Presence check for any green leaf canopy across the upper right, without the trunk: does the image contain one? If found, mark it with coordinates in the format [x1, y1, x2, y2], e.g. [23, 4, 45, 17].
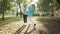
[38, 0, 60, 11]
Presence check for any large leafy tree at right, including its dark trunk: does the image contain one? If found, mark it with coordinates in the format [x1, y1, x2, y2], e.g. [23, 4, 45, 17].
[38, 0, 57, 16]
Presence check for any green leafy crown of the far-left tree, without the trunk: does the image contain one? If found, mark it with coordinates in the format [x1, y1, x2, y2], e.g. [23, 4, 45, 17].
[0, 0, 11, 13]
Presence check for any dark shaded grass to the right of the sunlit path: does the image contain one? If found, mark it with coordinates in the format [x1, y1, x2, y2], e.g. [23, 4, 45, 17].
[37, 17, 60, 34]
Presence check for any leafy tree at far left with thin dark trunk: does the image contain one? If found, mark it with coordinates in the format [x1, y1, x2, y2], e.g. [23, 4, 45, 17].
[0, 0, 10, 20]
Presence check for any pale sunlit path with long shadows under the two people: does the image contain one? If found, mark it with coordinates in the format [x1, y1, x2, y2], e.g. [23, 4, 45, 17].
[0, 17, 48, 34]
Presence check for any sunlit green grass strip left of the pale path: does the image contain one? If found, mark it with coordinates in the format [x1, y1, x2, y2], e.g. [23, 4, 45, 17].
[0, 16, 20, 27]
